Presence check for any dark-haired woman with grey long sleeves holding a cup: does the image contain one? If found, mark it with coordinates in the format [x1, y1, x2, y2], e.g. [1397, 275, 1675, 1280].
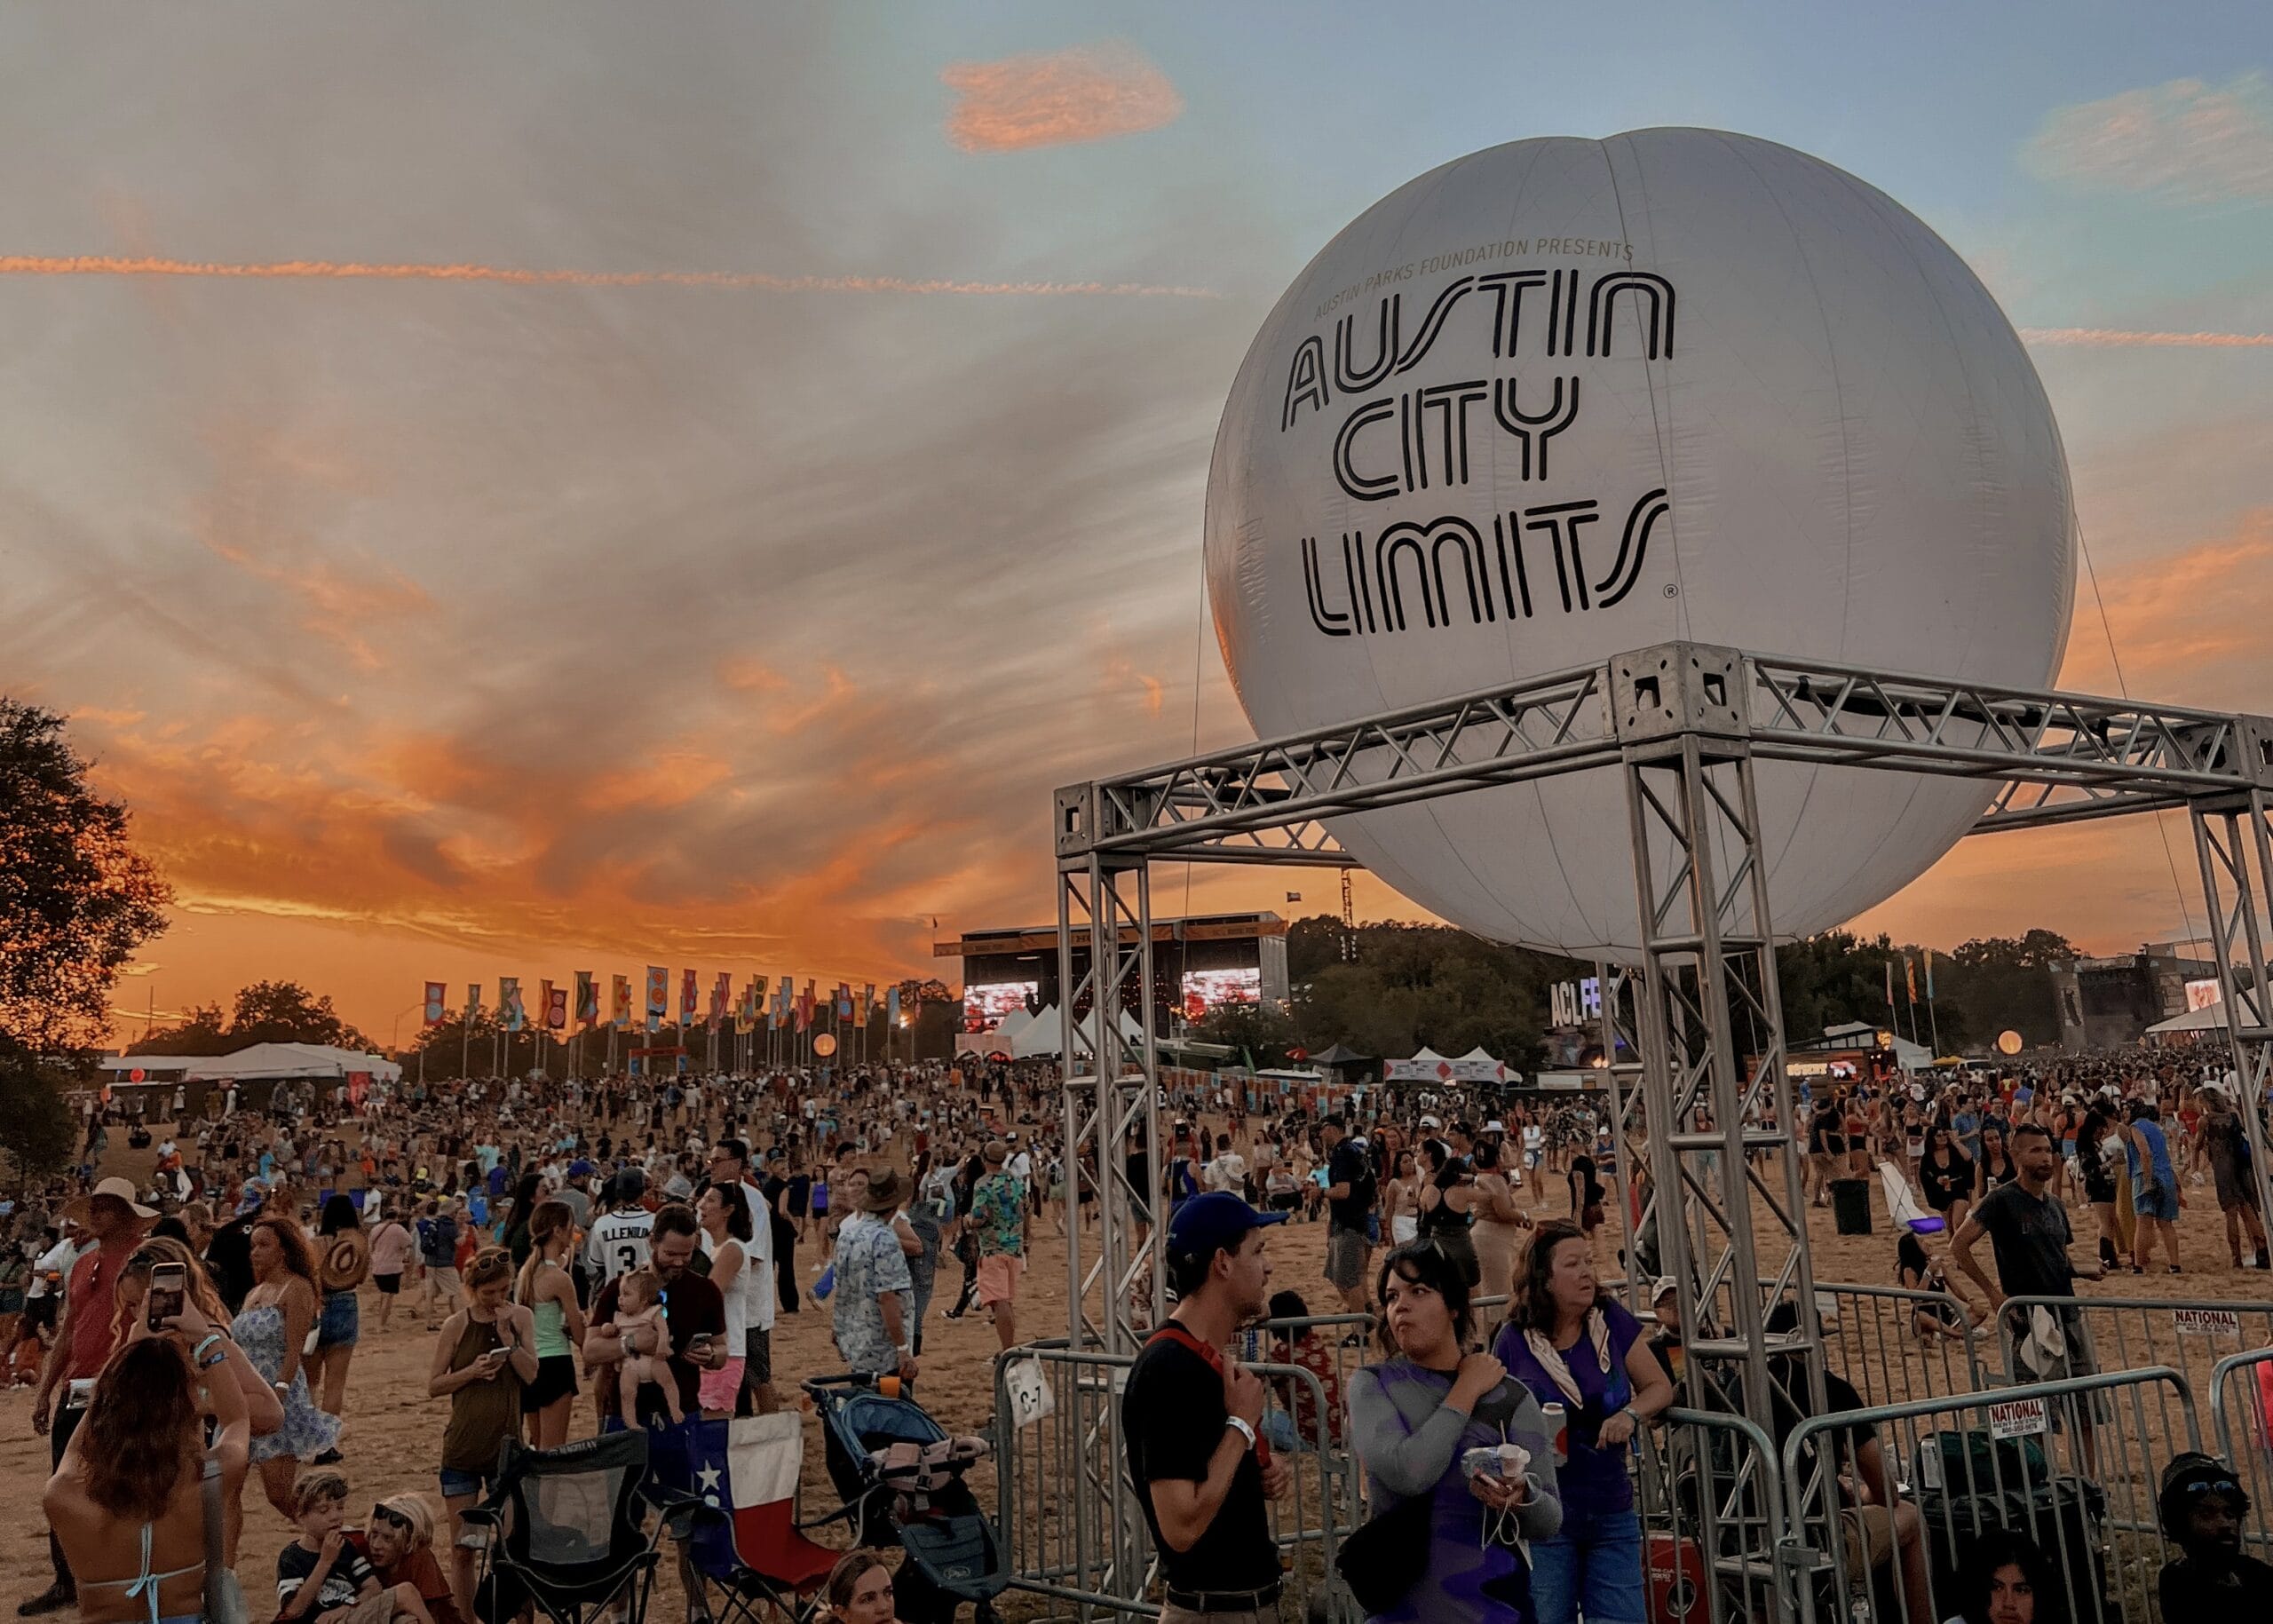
[1350, 1240, 1562, 1624]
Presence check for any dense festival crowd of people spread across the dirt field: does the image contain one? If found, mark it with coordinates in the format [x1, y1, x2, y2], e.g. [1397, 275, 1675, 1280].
[0, 1037, 2273, 1624]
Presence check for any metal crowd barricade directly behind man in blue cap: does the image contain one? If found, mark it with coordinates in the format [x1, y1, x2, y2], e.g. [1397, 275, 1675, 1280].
[994, 1340, 1359, 1624]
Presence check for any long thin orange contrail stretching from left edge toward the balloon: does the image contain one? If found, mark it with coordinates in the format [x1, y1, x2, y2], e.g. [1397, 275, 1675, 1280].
[0, 255, 1218, 298]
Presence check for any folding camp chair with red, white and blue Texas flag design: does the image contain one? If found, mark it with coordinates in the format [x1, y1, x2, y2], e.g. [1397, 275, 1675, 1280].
[648, 1410, 843, 1624]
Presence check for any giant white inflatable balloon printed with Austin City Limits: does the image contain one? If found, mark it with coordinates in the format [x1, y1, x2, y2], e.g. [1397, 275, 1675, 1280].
[1207, 130, 2075, 957]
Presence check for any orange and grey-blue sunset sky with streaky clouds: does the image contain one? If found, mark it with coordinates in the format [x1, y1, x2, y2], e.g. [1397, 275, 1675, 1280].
[0, 0, 2273, 1042]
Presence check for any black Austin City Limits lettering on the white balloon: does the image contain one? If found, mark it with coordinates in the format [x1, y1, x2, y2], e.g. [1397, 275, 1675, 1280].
[1279, 254, 1677, 637]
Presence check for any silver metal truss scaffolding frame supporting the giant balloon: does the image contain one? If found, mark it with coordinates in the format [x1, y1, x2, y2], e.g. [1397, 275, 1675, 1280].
[1052, 644, 2273, 1596]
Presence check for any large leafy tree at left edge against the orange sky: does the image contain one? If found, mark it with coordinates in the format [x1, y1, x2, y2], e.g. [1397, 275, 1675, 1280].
[0, 698, 173, 1053]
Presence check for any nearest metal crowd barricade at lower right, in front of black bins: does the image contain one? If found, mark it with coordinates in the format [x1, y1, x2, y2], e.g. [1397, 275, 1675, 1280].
[1782, 1365, 2200, 1624]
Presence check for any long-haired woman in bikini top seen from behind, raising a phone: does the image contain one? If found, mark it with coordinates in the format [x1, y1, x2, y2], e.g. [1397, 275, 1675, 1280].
[44, 1301, 250, 1624]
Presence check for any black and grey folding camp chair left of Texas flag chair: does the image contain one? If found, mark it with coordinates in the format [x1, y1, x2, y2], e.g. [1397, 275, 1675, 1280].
[463, 1430, 661, 1624]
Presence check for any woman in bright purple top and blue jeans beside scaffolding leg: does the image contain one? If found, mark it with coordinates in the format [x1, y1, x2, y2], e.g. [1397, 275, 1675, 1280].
[1491, 1222, 1673, 1624]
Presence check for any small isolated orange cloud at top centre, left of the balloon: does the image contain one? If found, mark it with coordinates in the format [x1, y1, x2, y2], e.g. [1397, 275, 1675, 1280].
[939, 44, 1184, 153]
